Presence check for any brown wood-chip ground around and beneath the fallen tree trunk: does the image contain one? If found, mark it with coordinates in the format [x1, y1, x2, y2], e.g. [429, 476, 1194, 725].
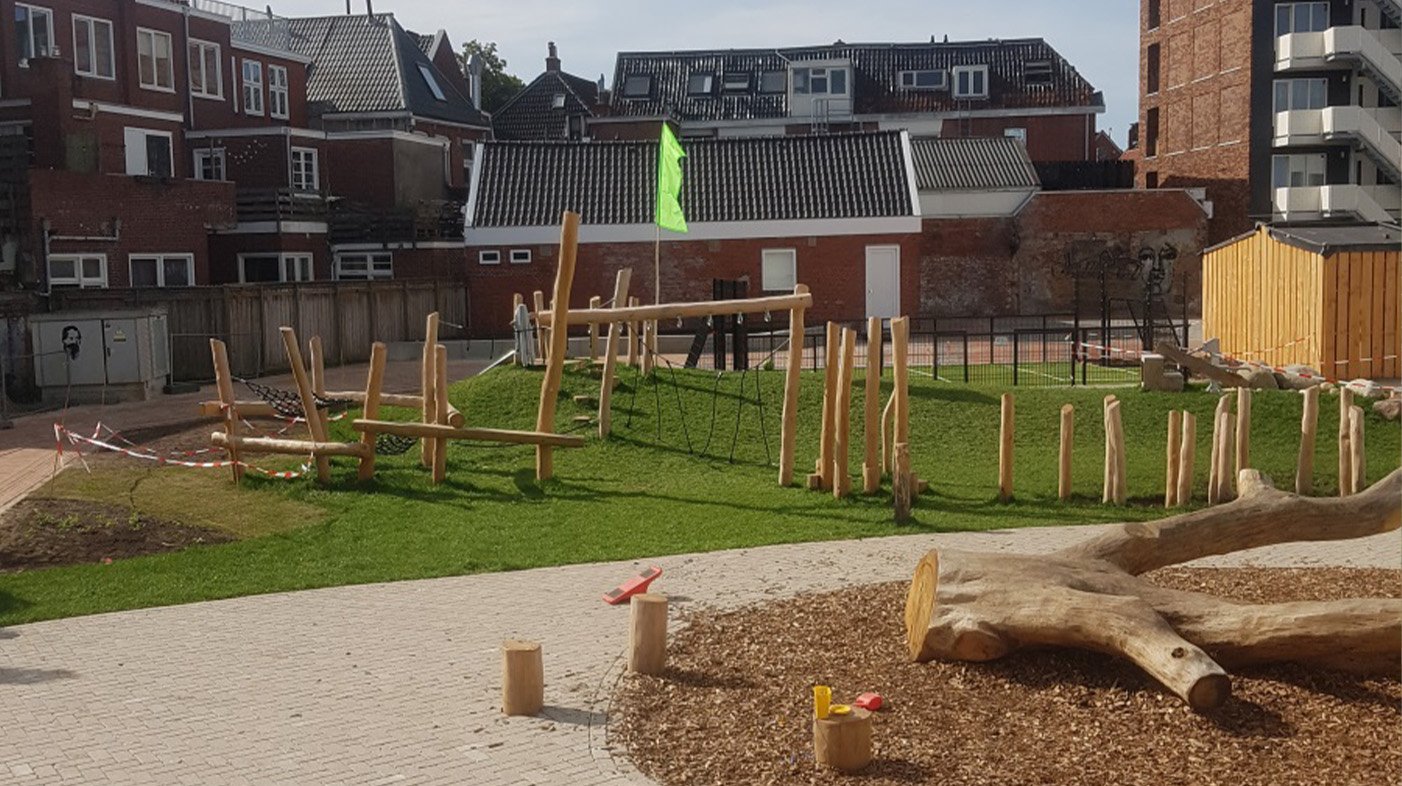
[610, 569, 1402, 786]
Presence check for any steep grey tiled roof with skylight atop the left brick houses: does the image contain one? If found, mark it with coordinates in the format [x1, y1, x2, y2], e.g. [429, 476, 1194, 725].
[234, 14, 489, 127]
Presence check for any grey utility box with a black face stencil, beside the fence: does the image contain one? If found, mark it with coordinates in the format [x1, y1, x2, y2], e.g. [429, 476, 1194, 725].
[29, 308, 171, 404]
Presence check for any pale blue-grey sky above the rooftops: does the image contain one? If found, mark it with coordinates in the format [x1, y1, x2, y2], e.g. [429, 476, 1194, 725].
[278, 0, 1140, 147]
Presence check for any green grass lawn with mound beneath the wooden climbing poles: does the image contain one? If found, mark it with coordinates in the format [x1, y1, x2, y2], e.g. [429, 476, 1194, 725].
[0, 367, 1402, 625]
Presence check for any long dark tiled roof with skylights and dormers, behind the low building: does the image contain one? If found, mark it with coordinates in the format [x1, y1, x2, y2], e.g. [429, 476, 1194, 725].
[611, 38, 1105, 122]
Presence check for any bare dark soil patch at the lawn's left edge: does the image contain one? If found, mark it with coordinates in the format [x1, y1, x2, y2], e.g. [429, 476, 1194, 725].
[0, 499, 233, 572]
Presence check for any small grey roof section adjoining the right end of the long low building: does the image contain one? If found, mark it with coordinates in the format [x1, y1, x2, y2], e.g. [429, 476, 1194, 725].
[910, 136, 1039, 191]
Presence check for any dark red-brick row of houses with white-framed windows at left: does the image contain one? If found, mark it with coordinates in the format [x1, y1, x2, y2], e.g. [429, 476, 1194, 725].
[0, 0, 489, 289]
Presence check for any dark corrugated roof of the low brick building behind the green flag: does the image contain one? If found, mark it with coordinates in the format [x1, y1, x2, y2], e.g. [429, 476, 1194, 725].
[472, 132, 914, 227]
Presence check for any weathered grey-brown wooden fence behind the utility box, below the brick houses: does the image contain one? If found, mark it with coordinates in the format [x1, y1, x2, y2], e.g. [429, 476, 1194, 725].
[53, 280, 467, 381]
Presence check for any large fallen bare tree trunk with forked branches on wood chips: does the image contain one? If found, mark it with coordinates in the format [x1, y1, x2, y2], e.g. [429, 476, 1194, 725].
[906, 469, 1402, 710]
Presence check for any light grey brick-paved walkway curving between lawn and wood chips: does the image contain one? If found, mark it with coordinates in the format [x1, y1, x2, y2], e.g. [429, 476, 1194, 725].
[0, 528, 1402, 786]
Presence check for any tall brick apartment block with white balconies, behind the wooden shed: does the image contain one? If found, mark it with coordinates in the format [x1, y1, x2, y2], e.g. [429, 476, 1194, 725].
[1137, 0, 1402, 242]
